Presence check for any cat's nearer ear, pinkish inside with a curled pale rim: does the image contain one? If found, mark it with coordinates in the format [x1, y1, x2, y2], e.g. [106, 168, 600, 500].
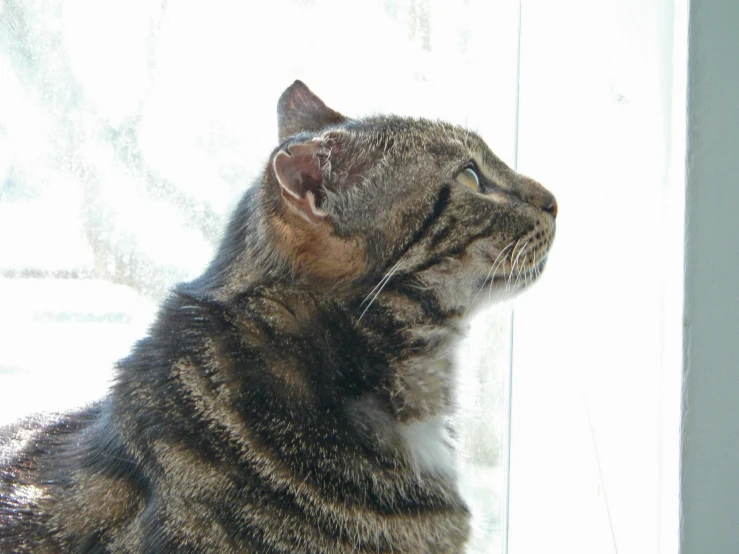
[273, 140, 327, 223]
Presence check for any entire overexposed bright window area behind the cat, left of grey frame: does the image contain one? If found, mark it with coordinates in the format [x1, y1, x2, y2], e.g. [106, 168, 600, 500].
[0, 0, 687, 554]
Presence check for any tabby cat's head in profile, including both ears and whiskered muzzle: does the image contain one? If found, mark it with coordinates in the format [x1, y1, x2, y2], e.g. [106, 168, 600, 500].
[261, 81, 557, 312]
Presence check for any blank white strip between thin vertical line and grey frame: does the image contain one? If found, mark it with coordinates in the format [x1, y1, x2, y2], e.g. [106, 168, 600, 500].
[510, 0, 687, 554]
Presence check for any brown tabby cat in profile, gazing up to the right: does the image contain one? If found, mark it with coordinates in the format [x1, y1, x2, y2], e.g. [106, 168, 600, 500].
[0, 81, 557, 554]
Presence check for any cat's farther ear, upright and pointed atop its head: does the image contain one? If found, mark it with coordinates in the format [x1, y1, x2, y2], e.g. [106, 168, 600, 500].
[277, 81, 347, 142]
